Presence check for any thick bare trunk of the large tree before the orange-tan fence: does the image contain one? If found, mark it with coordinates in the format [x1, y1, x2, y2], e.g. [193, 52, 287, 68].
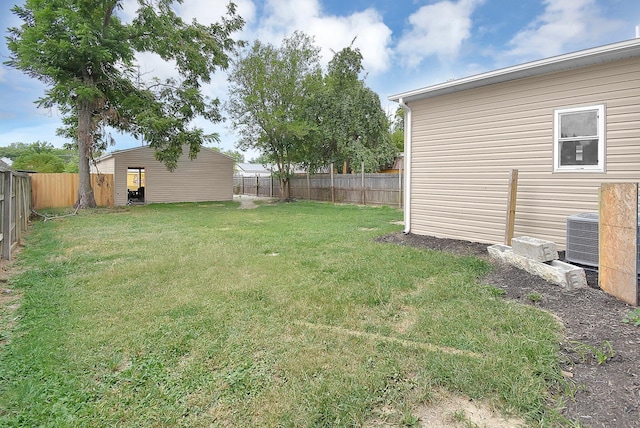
[75, 99, 97, 208]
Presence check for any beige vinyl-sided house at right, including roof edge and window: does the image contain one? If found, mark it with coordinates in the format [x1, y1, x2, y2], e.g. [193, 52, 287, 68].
[389, 39, 640, 248]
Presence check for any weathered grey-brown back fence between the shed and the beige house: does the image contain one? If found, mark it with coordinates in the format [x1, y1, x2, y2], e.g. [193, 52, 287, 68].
[233, 174, 404, 207]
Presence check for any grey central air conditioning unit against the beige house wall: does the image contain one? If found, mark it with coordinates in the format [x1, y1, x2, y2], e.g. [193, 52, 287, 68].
[564, 213, 599, 266]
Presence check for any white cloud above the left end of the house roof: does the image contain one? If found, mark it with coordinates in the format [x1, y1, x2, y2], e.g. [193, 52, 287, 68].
[397, 0, 484, 67]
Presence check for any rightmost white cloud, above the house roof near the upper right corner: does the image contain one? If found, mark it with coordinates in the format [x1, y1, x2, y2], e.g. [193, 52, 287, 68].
[506, 0, 621, 60]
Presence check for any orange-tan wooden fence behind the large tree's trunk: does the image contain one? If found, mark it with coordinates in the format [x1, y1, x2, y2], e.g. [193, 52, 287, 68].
[31, 173, 113, 210]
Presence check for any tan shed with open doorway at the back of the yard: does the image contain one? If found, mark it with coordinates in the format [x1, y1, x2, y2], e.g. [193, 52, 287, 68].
[92, 146, 234, 206]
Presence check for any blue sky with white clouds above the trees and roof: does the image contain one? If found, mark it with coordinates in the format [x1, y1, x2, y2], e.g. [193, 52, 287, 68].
[0, 0, 640, 160]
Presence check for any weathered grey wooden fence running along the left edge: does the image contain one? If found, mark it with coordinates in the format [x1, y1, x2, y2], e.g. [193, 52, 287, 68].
[0, 169, 31, 260]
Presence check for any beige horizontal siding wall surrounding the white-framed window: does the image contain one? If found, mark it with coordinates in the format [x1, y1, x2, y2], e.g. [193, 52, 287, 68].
[409, 58, 640, 248]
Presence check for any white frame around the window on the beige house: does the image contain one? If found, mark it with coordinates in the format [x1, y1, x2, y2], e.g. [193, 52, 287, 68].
[553, 104, 606, 172]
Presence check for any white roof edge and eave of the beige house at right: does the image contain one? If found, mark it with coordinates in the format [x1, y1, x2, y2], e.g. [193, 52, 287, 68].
[389, 39, 640, 103]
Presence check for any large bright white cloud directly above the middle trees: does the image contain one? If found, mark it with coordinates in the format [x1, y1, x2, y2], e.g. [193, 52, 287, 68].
[255, 0, 391, 74]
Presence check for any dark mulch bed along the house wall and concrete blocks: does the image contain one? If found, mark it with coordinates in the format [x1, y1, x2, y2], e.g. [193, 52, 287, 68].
[379, 233, 640, 428]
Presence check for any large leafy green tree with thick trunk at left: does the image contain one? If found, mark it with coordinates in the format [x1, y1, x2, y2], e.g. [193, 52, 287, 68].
[5, 0, 243, 207]
